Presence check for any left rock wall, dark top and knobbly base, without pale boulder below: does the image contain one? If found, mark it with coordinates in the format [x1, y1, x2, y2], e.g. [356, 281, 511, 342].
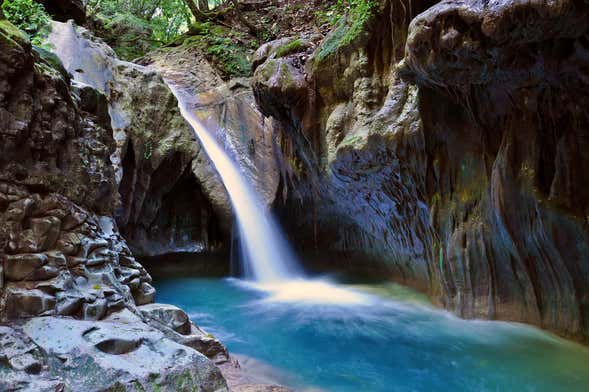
[0, 22, 153, 321]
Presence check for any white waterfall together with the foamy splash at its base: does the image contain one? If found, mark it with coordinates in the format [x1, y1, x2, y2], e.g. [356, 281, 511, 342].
[168, 82, 370, 304]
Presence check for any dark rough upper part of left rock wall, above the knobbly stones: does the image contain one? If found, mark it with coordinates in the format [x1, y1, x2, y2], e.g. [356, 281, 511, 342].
[0, 21, 114, 214]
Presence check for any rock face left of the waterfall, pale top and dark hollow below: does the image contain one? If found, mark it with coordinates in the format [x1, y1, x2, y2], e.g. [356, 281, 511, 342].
[44, 22, 225, 257]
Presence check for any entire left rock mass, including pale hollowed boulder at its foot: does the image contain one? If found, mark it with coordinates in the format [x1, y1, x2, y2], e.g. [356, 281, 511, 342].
[0, 20, 228, 391]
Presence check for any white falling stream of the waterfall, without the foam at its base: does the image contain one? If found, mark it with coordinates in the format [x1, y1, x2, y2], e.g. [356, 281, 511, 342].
[168, 83, 302, 283]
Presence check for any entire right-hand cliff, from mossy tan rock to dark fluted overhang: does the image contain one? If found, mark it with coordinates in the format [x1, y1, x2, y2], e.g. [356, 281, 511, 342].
[252, 0, 589, 339]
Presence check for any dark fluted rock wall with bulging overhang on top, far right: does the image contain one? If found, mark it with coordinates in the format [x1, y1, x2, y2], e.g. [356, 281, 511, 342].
[404, 1, 589, 339]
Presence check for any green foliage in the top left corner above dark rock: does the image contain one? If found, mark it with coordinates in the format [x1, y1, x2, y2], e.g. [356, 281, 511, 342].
[2, 0, 51, 44]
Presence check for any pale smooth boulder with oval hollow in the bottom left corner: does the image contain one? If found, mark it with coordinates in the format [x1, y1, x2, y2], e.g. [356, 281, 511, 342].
[0, 311, 227, 391]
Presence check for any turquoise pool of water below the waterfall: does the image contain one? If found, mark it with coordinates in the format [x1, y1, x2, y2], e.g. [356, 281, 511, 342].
[157, 278, 589, 391]
